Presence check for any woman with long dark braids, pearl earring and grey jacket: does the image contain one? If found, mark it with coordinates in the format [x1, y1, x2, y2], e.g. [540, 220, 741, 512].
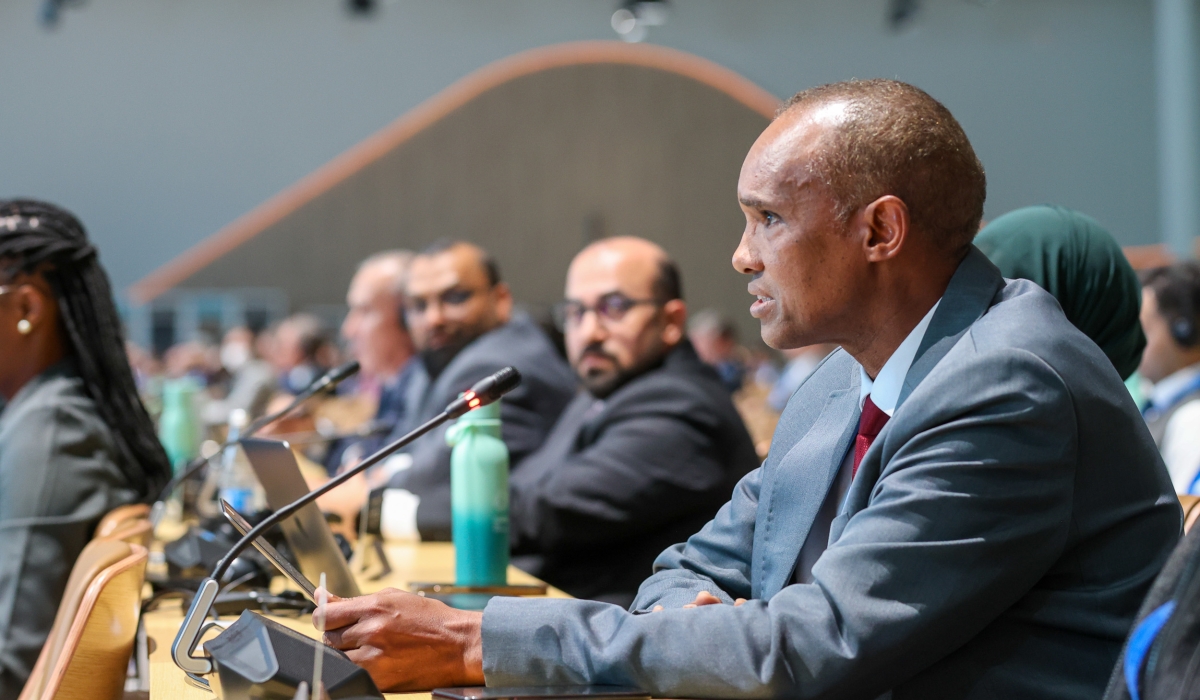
[0, 201, 170, 700]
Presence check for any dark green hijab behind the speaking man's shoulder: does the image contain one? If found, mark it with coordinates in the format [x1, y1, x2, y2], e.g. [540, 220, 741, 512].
[974, 207, 1146, 379]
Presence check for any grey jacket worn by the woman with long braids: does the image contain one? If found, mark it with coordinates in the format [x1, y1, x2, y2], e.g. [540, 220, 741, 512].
[0, 363, 137, 700]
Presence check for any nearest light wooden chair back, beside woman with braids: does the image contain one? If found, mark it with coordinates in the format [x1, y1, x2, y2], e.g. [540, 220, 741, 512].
[19, 539, 146, 700]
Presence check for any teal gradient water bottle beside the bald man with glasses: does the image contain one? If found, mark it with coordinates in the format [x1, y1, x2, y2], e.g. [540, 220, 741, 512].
[446, 401, 509, 586]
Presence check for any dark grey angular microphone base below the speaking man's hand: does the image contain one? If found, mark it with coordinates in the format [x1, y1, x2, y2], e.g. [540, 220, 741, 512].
[204, 610, 383, 700]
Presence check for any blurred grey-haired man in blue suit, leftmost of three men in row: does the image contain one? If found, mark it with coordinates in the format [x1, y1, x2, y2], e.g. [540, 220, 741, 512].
[325, 251, 421, 473]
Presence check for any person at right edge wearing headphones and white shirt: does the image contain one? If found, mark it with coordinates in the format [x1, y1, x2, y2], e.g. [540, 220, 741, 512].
[1140, 262, 1200, 493]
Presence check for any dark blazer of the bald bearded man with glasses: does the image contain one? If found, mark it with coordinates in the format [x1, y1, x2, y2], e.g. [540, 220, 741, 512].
[510, 340, 758, 606]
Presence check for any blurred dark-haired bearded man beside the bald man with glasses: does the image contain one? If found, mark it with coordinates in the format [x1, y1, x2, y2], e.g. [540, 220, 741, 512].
[380, 241, 576, 540]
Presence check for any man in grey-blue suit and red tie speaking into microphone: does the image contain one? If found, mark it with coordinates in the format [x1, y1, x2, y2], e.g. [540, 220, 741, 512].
[316, 80, 1181, 700]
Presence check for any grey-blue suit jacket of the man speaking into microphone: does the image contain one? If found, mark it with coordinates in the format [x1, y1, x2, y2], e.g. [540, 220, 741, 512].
[484, 249, 1181, 700]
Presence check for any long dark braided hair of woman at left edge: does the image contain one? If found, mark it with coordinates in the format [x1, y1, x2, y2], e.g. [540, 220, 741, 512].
[0, 199, 170, 498]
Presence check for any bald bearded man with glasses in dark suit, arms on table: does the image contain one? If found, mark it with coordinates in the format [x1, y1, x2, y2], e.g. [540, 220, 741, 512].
[510, 238, 758, 606]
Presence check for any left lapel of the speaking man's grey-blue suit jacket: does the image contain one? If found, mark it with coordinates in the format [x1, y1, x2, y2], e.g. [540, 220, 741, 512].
[751, 365, 859, 599]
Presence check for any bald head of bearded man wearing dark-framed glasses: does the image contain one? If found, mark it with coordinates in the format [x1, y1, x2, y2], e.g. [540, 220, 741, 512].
[559, 238, 688, 399]
